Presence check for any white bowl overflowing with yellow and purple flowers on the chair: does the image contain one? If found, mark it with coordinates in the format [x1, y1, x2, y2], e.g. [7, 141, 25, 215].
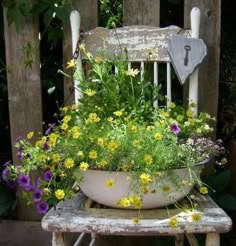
[4, 46, 224, 226]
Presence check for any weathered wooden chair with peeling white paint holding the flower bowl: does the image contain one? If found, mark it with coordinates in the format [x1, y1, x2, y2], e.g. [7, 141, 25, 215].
[42, 8, 232, 246]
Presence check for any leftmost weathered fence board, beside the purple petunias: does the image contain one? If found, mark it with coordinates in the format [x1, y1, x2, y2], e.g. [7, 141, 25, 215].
[4, 6, 42, 220]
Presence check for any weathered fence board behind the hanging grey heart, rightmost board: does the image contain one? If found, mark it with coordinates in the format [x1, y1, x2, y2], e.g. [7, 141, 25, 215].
[184, 0, 221, 135]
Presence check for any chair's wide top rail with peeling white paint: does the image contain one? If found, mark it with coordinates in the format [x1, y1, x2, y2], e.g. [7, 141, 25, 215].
[81, 25, 190, 62]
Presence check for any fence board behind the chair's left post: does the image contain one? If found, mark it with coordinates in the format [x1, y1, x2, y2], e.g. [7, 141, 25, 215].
[63, 0, 98, 104]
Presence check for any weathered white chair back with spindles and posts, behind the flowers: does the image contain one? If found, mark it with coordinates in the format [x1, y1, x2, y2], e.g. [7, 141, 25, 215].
[71, 10, 203, 114]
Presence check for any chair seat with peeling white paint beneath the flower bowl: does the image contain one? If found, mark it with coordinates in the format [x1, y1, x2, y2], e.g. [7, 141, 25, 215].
[42, 192, 232, 236]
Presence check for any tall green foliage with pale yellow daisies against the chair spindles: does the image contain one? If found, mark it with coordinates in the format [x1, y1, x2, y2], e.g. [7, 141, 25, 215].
[76, 45, 160, 120]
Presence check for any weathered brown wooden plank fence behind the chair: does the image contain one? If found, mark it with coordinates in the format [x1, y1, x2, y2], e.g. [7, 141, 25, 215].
[0, 0, 221, 220]
